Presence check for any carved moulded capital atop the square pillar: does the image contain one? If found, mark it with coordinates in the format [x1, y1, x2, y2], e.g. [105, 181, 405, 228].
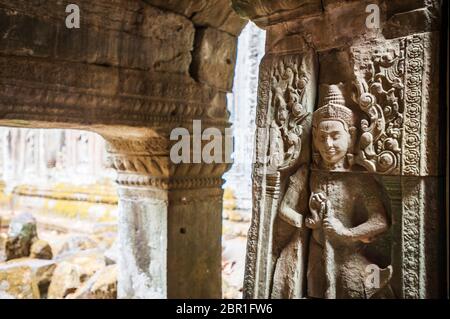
[107, 136, 231, 196]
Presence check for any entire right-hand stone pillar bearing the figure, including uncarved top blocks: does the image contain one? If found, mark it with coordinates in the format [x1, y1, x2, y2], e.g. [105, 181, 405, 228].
[233, 0, 448, 298]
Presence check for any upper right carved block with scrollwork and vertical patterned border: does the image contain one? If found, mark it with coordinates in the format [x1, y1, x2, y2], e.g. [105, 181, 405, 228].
[352, 35, 429, 176]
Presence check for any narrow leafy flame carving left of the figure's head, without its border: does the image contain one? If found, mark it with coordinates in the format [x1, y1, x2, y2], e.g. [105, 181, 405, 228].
[267, 57, 309, 170]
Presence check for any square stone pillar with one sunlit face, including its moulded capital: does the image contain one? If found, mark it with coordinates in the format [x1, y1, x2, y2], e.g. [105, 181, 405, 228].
[107, 131, 229, 298]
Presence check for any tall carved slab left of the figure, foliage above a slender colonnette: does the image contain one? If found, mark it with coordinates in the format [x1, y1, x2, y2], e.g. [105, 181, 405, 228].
[245, 51, 318, 297]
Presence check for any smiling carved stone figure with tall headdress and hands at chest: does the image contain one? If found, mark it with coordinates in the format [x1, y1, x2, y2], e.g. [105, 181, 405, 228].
[272, 85, 392, 298]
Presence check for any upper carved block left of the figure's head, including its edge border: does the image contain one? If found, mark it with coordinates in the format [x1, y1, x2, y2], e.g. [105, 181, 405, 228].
[256, 52, 316, 171]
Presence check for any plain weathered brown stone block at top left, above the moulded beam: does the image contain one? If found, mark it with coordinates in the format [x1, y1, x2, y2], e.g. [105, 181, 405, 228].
[0, 1, 194, 74]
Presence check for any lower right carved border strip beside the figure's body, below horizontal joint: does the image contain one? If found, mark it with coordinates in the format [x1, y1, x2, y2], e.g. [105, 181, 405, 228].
[381, 176, 443, 299]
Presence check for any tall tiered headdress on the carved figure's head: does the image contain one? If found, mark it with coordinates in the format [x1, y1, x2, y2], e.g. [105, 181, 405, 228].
[313, 84, 355, 131]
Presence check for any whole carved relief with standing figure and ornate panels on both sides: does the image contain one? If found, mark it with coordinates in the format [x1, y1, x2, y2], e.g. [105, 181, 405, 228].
[244, 34, 437, 298]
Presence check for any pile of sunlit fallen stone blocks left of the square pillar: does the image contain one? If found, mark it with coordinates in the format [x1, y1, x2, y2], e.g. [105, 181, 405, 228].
[0, 213, 117, 299]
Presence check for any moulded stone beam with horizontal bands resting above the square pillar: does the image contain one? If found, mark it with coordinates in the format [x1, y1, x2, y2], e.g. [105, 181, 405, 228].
[0, 57, 226, 130]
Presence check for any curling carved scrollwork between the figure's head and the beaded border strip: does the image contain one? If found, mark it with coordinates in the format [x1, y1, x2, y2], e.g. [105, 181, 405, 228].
[353, 50, 404, 174]
